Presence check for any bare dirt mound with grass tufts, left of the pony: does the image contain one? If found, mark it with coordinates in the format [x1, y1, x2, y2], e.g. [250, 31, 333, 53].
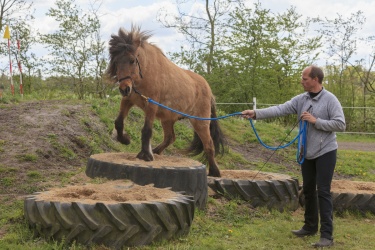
[0, 101, 110, 196]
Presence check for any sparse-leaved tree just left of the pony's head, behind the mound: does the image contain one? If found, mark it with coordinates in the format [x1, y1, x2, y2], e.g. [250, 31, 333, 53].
[41, 0, 104, 99]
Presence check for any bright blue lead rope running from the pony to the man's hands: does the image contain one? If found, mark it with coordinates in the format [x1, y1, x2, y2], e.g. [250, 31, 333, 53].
[146, 97, 307, 164]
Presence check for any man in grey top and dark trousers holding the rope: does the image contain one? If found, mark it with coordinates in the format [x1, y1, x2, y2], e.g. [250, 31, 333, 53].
[242, 66, 346, 247]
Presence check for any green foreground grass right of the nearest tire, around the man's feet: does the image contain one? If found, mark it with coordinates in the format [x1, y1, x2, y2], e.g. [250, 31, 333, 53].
[145, 207, 375, 249]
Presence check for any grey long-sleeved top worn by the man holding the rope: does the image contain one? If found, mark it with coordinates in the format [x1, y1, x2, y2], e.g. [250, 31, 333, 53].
[255, 88, 346, 159]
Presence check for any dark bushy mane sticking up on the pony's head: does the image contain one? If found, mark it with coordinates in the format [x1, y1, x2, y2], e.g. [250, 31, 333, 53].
[107, 25, 152, 78]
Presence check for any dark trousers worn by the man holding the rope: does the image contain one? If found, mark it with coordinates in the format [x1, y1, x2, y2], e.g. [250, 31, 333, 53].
[301, 150, 337, 239]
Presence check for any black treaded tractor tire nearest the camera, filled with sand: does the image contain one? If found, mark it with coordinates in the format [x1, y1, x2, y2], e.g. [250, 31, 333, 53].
[24, 181, 194, 249]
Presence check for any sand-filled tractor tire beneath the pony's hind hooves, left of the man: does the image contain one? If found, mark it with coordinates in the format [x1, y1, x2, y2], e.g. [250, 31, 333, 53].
[208, 170, 299, 211]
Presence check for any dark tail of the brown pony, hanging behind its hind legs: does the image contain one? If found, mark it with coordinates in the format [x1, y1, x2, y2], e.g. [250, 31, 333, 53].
[188, 97, 227, 156]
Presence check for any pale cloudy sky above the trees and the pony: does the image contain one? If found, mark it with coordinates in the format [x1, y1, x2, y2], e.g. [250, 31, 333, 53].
[8, 0, 375, 67]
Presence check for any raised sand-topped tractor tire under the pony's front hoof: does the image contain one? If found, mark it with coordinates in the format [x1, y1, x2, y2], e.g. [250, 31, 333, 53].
[86, 153, 208, 210]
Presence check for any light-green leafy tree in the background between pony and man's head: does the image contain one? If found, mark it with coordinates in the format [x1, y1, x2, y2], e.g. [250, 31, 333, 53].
[211, 4, 276, 105]
